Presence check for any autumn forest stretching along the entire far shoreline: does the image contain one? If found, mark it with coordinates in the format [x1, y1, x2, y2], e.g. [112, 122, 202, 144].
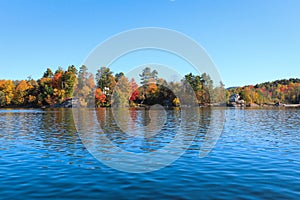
[0, 65, 300, 108]
